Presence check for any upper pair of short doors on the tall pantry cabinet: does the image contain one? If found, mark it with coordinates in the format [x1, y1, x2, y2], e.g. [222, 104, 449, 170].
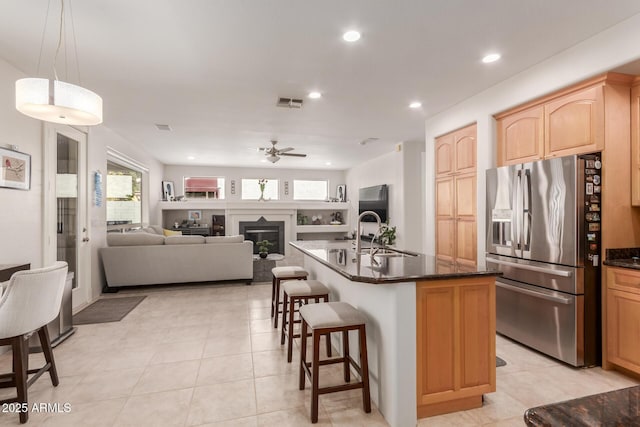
[435, 124, 476, 176]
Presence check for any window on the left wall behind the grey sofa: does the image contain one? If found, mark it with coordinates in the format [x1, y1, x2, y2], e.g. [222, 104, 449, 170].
[106, 161, 142, 229]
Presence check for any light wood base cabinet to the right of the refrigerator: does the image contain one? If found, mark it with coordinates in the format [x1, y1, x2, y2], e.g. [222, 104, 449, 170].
[603, 267, 640, 375]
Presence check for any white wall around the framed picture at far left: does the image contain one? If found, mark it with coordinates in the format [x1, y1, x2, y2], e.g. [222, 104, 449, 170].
[0, 59, 43, 268]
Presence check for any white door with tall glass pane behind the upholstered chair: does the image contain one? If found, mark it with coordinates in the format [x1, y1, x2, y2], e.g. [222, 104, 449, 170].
[43, 123, 91, 310]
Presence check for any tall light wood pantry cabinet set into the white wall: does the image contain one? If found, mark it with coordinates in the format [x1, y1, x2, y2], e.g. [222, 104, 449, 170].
[435, 124, 477, 266]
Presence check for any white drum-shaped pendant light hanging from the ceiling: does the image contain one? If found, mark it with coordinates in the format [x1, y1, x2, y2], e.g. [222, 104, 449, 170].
[16, 0, 102, 126]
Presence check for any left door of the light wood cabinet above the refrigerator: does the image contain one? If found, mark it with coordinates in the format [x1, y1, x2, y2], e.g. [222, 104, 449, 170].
[497, 105, 544, 166]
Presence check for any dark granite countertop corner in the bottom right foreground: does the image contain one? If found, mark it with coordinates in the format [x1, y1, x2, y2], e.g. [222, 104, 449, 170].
[524, 386, 640, 427]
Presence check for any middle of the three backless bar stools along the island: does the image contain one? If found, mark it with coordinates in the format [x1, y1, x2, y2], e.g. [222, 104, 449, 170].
[280, 280, 331, 363]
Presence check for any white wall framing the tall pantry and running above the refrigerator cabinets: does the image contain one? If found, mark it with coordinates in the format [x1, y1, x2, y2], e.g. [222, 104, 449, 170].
[424, 15, 640, 260]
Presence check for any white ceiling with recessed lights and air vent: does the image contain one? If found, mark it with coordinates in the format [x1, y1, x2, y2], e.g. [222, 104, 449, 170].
[0, 0, 640, 169]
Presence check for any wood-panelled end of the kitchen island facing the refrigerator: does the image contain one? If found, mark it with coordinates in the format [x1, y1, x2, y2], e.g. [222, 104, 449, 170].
[416, 277, 496, 418]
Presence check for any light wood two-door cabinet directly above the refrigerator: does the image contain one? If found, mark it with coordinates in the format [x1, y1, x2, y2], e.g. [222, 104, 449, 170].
[495, 73, 633, 166]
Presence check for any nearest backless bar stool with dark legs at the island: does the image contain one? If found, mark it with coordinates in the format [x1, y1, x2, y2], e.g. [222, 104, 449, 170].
[299, 302, 371, 423]
